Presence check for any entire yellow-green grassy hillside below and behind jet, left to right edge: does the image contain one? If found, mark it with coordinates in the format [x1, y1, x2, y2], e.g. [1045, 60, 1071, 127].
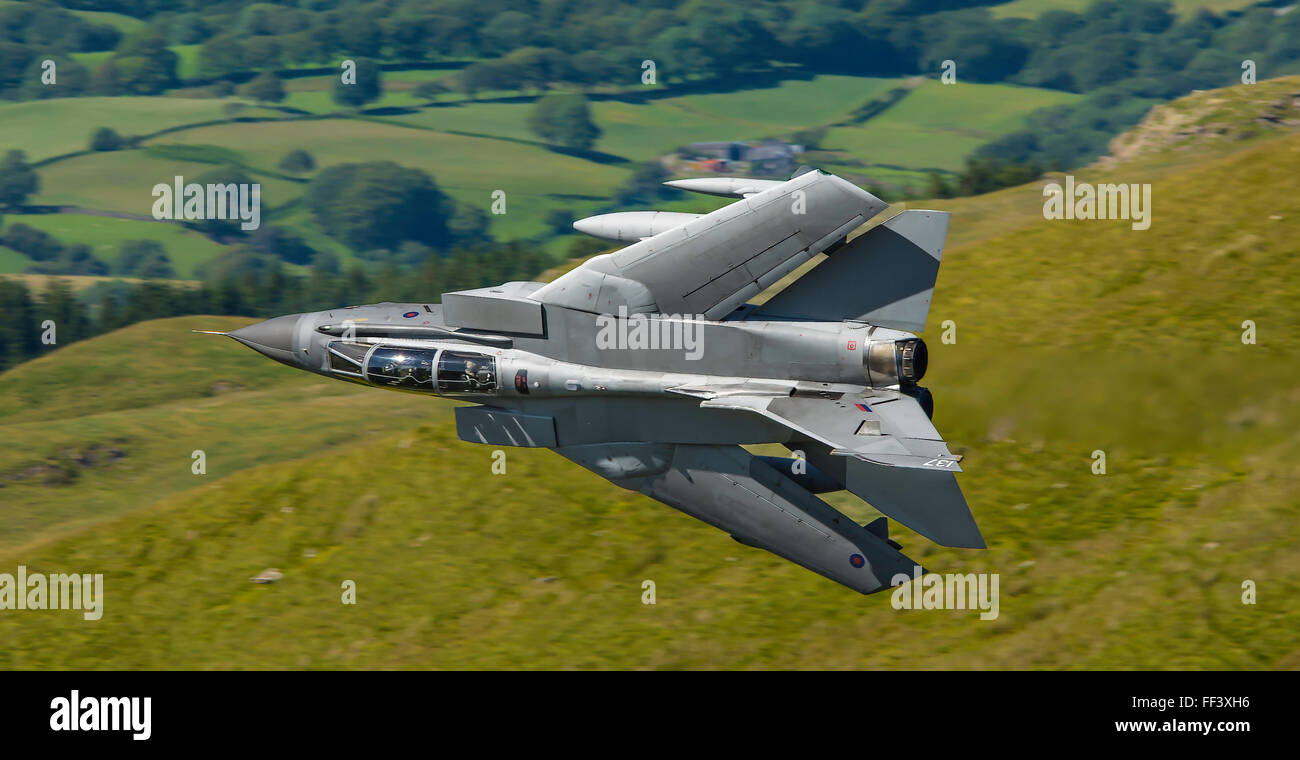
[0, 83, 1300, 669]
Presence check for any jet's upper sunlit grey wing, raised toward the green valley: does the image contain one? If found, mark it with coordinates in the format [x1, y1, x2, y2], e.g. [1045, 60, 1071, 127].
[529, 171, 887, 320]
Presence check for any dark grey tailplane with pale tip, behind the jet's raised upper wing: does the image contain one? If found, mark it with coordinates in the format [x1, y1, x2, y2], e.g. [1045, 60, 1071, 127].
[746, 210, 949, 333]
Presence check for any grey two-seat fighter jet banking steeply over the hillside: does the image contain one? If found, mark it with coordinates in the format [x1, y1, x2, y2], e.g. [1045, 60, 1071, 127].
[208, 170, 984, 594]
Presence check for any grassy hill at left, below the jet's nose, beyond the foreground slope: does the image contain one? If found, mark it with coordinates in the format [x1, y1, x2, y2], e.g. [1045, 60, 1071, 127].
[0, 317, 439, 547]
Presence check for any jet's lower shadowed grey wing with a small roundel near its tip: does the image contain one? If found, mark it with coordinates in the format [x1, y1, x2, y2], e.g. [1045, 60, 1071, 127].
[555, 443, 924, 594]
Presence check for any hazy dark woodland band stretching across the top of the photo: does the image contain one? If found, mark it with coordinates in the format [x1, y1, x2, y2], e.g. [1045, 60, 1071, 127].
[10, 0, 1300, 103]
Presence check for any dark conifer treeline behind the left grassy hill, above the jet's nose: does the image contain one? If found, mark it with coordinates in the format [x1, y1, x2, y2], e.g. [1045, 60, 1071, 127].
[0, 243, 553, 372]
